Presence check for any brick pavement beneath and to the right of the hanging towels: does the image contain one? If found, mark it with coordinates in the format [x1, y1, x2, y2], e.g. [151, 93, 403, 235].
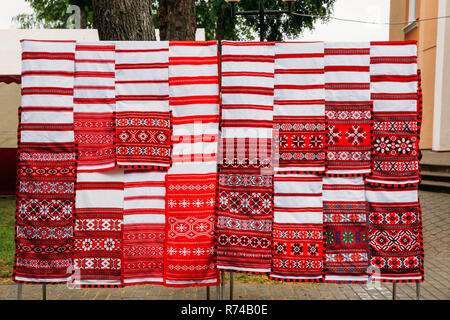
[0, 192, 450, 300]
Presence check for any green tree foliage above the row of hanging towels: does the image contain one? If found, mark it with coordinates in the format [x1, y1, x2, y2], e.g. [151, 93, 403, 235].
[14, 0, 335, 41]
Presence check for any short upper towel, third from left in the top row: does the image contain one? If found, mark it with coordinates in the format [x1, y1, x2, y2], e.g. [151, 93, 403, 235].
[116, 41, 171, 170]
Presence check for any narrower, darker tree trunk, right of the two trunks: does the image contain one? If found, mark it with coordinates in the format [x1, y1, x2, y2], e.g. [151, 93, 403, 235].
[158, 0, 197, 40]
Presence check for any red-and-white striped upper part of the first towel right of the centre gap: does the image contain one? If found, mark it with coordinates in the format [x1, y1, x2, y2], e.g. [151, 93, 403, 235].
[221, 41, 275, 138]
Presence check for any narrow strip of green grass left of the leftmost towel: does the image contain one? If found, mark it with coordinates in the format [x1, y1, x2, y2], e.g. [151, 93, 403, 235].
[0, 197, 16, 282]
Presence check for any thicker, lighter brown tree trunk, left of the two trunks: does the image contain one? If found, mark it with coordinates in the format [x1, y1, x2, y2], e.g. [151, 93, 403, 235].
[92, 0, 156, 40]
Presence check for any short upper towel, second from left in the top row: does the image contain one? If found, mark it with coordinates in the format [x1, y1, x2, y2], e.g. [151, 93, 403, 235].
[73, 42, 115, 172]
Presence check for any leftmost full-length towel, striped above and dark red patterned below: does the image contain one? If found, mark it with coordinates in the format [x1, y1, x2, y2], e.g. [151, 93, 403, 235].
[13, 40, 76, 283]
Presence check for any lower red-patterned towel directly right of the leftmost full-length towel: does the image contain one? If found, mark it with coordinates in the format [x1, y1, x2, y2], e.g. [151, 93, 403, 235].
[73, 168, 124, 287]
